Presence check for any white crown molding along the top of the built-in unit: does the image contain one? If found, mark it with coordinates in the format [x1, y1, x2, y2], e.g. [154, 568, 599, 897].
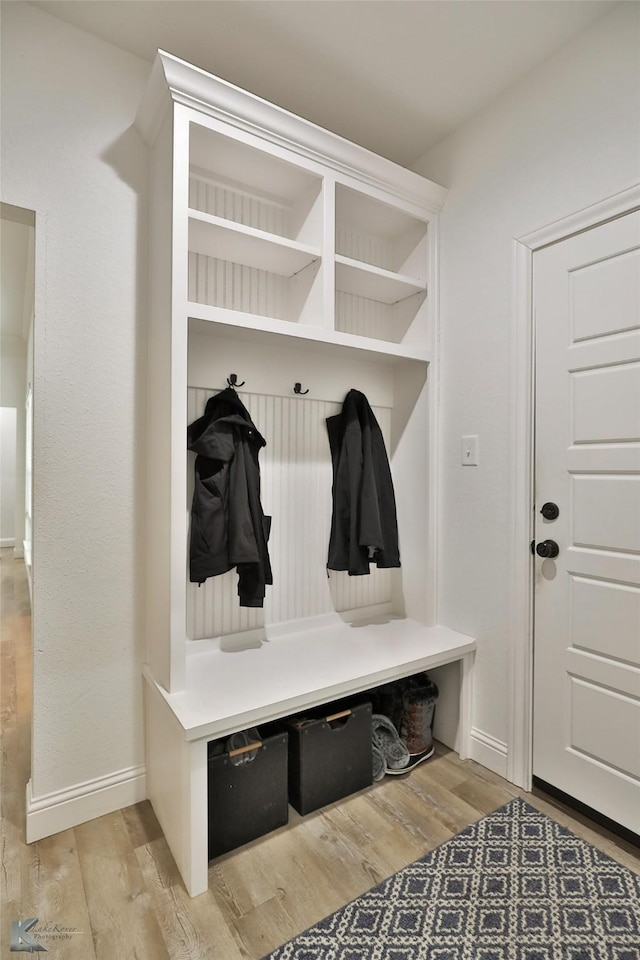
[135, 50, 448, 213]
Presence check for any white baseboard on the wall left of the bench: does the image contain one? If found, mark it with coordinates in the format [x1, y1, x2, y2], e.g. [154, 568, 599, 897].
[27, 766, 147, 843]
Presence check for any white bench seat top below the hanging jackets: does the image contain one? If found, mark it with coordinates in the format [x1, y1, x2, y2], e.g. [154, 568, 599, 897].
[145, 617, 476, 740]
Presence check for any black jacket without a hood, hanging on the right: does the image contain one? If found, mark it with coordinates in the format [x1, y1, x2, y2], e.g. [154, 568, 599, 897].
[327, 390, 400, 576]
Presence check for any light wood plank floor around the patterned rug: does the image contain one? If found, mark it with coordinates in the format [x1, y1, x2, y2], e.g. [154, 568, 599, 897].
[0, 550, 640, 960]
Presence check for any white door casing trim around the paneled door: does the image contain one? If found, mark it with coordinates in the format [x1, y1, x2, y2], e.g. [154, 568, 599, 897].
[508, 183, 640, 790]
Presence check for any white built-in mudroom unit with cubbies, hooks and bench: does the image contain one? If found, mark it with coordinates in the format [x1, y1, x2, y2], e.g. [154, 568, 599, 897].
[137, 52, 475, 896]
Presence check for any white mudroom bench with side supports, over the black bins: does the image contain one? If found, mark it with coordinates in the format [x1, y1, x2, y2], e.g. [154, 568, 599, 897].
[145, 615, 476, 896]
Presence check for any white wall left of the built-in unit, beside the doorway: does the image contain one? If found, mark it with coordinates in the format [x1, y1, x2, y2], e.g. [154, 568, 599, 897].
[1, 3, 149, 824]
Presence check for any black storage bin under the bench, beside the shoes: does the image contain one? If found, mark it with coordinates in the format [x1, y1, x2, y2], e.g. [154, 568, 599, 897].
[287, 703, 373, 814]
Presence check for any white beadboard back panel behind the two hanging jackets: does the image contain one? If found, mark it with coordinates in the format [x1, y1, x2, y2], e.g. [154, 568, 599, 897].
[187, 387, 391, 640]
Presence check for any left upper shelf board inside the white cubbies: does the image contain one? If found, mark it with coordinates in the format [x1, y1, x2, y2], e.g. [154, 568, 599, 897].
[189, 210, 320, 277]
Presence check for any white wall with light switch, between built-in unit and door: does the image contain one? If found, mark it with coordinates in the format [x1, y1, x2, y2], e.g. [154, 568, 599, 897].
[416, 3, 640, 772]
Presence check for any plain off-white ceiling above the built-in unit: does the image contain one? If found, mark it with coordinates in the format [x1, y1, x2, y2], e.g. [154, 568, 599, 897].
[33, 0, 614, 166]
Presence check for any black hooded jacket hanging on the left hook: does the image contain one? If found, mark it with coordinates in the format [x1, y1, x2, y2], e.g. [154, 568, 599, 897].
[187, 389, 273, 607]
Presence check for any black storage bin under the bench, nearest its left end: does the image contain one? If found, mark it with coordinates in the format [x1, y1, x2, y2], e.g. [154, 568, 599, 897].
[208, 727, 289, 860]
